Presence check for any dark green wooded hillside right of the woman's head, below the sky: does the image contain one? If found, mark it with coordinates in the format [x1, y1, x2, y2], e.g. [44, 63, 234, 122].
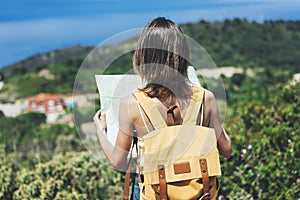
[183, 19, 300, 70]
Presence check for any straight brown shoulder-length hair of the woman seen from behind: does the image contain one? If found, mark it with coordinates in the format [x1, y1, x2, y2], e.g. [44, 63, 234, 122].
[133, 17, 192, 106]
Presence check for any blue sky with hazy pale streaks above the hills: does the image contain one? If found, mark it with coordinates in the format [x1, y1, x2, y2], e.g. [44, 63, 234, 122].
[0, 0, 300, 67]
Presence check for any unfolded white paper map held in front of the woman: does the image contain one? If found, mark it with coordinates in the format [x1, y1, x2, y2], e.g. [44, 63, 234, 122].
[95, 66, 200, 145]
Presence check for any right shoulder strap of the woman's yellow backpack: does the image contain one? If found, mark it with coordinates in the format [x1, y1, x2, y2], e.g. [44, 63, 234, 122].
[183, 86, 204, 124]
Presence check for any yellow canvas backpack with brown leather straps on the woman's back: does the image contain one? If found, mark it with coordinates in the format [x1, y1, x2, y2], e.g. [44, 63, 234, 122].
[134, 87, 221, 200]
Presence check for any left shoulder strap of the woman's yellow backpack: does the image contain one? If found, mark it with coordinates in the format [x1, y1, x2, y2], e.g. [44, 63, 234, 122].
[133, 91, 167, 130]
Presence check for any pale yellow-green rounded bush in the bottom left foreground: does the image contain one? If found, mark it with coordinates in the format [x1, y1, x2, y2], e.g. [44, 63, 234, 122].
[13, 153, 122, 199]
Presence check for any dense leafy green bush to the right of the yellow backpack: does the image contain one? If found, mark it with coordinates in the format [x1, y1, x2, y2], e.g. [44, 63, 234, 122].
[220, 84, 300, 199]
